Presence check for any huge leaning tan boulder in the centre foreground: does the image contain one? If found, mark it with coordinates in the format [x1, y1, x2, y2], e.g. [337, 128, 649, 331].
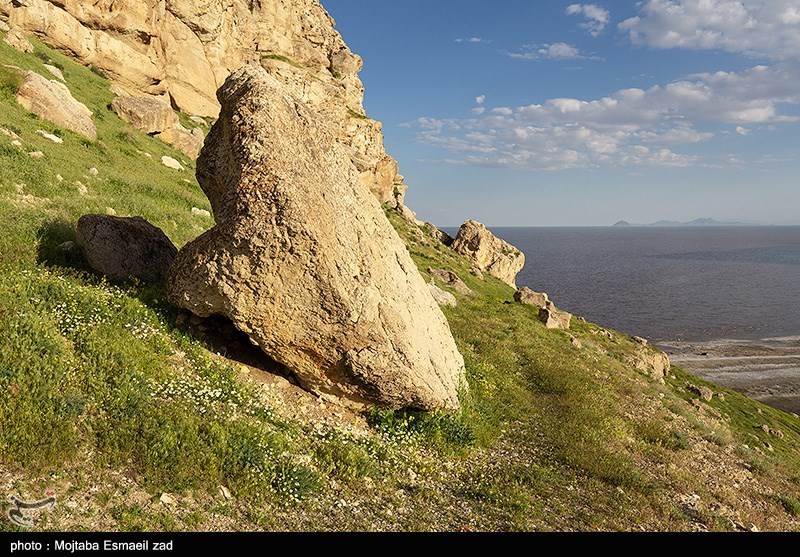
[167, 65, 464, 409]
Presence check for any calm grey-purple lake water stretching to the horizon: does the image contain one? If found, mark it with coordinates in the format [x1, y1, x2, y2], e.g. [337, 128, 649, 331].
[448, 227, 800, 342]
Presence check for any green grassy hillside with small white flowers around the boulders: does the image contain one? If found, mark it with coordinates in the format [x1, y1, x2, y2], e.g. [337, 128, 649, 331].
[0, 26, 800, 530]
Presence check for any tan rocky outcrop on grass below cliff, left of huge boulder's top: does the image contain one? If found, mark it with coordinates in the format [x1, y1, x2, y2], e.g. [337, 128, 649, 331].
[111, 95, 205, 159]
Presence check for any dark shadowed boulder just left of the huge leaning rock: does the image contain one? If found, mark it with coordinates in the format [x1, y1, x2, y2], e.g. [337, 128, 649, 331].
[77, 215, 178, 284]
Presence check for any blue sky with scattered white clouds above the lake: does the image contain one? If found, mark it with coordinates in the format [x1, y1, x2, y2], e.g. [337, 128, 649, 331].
[323, 0, 800, 226]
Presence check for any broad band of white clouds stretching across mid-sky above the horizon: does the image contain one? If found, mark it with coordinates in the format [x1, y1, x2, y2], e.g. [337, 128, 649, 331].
[415, 66, 800, 169]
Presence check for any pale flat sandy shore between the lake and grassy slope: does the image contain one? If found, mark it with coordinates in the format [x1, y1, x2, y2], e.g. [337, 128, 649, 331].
[658, 336, 800, 414]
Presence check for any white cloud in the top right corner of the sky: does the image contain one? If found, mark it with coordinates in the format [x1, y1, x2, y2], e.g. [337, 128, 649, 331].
[619, 0, 800, 60]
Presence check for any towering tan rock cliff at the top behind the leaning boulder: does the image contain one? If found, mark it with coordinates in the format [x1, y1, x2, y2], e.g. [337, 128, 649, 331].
[0, 0, 403, 203]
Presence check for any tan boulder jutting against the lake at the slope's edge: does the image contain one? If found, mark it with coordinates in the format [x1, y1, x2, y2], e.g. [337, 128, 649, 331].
[452, 220, 525, 287]
